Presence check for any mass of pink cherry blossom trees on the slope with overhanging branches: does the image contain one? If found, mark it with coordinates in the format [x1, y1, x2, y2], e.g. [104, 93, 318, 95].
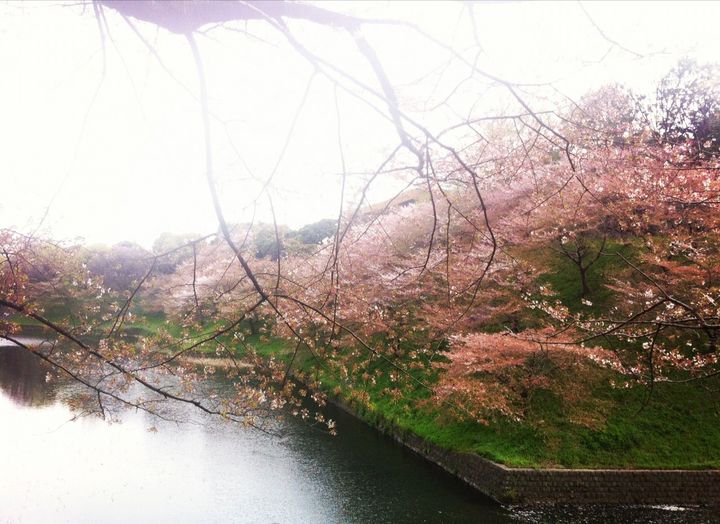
[0, 0, 720, 429]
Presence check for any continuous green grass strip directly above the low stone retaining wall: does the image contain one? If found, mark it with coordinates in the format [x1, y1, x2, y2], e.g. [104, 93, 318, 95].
[288, 342, 720, 469]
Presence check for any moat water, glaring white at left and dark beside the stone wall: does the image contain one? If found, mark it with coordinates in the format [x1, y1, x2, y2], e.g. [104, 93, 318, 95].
[0, 347, 720, 524]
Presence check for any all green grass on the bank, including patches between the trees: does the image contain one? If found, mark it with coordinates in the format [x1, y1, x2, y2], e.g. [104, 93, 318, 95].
[14, 244, 720, 469]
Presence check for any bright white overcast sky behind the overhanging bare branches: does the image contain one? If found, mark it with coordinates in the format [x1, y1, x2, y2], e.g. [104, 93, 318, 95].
[0, 2, 720, 247]
